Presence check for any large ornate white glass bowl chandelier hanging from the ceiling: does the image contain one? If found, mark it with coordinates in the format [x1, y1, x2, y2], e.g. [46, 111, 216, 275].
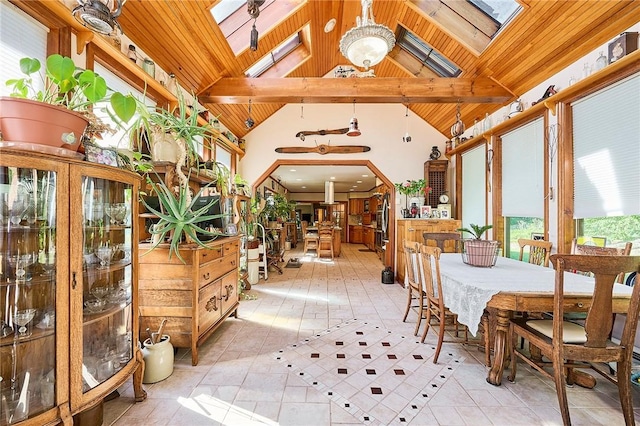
[340, 0, 396, 70]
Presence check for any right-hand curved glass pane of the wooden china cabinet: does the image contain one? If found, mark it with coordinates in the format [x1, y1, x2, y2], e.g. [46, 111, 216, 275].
[82, 176, 134, 392]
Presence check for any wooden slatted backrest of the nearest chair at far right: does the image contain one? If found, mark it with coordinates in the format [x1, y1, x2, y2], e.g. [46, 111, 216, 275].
[551, 254, 640, 350]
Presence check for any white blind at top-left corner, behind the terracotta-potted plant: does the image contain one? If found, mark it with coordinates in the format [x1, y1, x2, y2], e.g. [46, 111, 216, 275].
[0, 1, 48, 96]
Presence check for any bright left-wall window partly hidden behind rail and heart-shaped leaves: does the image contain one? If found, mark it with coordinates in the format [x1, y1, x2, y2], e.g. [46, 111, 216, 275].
[93, 62, 156, 148]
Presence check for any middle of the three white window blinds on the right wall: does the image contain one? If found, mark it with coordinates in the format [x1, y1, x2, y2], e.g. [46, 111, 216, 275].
[502, 118, 544, 217]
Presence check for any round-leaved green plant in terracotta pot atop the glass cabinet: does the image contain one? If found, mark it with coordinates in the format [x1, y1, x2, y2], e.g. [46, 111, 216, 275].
[0, 54, 136, 151]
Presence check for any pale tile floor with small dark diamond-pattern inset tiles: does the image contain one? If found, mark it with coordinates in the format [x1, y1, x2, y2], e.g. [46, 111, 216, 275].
[104, 244, 640, 426]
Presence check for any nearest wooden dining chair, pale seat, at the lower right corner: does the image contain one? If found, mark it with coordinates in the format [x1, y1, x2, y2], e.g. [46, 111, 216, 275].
[508, 254, 640, 425]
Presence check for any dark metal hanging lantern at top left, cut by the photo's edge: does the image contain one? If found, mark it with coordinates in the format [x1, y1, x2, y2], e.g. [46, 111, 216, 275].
[71, 0, 127, 35]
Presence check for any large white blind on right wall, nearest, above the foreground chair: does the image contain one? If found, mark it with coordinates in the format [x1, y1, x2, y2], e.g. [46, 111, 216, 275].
[571, 74, 640, 218]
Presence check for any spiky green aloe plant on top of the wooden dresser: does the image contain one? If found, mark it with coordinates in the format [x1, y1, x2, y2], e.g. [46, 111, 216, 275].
[140, 178, 224, 263]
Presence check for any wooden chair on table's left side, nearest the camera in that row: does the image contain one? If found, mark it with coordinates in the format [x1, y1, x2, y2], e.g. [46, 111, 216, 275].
[420, 245, 491, 366]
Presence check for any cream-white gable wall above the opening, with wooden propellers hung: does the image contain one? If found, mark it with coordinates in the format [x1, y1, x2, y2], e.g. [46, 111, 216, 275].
[239, 104, 454, 190]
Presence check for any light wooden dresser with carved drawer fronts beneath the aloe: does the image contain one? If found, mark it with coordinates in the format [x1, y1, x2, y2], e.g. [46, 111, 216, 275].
[139, 236, 240, 365]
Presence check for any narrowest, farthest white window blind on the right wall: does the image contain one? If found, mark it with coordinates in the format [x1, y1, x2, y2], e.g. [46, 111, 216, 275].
[462, 145, 487, 228]
